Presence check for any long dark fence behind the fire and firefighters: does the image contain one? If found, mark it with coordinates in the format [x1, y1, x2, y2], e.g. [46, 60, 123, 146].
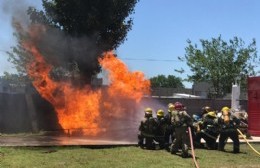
[0, 93, 247, 133]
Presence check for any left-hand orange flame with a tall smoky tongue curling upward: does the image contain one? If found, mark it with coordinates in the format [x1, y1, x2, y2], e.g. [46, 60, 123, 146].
[24, 43, 101, 135]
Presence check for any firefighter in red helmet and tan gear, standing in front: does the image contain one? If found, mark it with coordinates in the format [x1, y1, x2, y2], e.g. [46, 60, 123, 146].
[170, 102, 192, 158]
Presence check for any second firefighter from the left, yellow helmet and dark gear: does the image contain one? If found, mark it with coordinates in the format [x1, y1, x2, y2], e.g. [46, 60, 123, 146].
[155, 109, 167, 149]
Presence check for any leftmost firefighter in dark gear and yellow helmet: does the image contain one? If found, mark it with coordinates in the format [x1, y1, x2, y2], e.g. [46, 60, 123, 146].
[138, 107, 156, 149]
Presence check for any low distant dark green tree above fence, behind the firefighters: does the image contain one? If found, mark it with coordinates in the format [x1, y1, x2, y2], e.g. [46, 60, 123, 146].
[150, 75, 184, 88]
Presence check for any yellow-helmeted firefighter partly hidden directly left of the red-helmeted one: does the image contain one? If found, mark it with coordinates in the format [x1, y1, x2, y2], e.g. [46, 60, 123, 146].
[164, 103, 175, 150]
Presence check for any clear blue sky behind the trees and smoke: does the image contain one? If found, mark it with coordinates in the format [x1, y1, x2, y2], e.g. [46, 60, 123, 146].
[0, 0, 260, 88]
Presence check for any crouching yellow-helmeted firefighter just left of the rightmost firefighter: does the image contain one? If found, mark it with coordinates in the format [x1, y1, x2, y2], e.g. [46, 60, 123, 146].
[194, 111, 219, 150]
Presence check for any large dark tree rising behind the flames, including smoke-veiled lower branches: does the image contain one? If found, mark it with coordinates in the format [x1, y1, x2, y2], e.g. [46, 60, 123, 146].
[9, 0, 138, 83]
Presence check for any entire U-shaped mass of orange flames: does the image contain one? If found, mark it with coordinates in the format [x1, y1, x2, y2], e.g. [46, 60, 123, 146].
[23, 25, 150, 135]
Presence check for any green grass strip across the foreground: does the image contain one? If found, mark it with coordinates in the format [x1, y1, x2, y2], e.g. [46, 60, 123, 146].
[0, 144, 260, 168]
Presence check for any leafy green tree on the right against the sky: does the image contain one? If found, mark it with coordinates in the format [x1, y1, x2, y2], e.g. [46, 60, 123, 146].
[185, 35, 259, 97]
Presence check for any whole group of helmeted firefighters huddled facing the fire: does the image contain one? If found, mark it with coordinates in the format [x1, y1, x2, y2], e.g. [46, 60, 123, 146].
[138, 102, 243, 158]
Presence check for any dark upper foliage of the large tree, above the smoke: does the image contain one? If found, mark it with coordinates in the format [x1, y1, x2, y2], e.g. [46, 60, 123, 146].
[39, 0, 137, 51]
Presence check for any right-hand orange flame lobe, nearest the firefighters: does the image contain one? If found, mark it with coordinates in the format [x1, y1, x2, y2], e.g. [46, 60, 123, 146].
[99, 52, 150, 102]
